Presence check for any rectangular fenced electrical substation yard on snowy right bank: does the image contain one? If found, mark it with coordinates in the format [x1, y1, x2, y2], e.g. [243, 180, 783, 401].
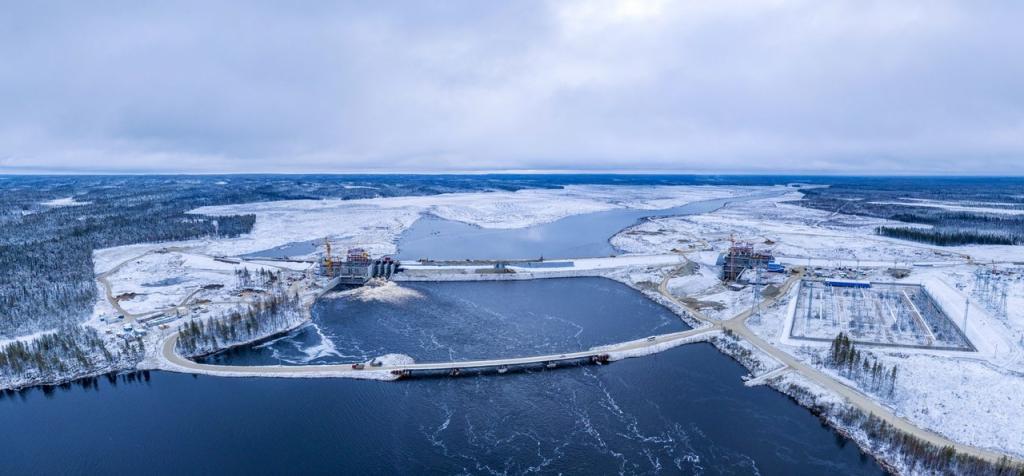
[790, 279, 974, 351]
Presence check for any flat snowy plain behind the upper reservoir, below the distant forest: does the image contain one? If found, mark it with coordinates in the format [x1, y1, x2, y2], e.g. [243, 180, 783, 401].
[194, 185, 770, 260]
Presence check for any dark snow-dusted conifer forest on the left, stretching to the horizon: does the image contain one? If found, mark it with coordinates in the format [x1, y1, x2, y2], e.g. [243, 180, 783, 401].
[0, 175, 569, 340]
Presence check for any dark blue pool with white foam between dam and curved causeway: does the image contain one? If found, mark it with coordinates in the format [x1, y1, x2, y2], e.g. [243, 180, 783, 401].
[200, 277, 689, 364]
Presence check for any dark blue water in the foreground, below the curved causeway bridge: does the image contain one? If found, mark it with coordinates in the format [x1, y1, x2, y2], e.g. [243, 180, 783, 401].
[0, 344, 882, 475]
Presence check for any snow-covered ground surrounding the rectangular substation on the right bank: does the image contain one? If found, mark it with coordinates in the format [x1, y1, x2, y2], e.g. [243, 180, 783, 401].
[612, 190, 1024, 456]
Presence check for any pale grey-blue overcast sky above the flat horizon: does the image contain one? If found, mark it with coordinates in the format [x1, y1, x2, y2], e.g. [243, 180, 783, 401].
[0, 0, 1024, 175]
